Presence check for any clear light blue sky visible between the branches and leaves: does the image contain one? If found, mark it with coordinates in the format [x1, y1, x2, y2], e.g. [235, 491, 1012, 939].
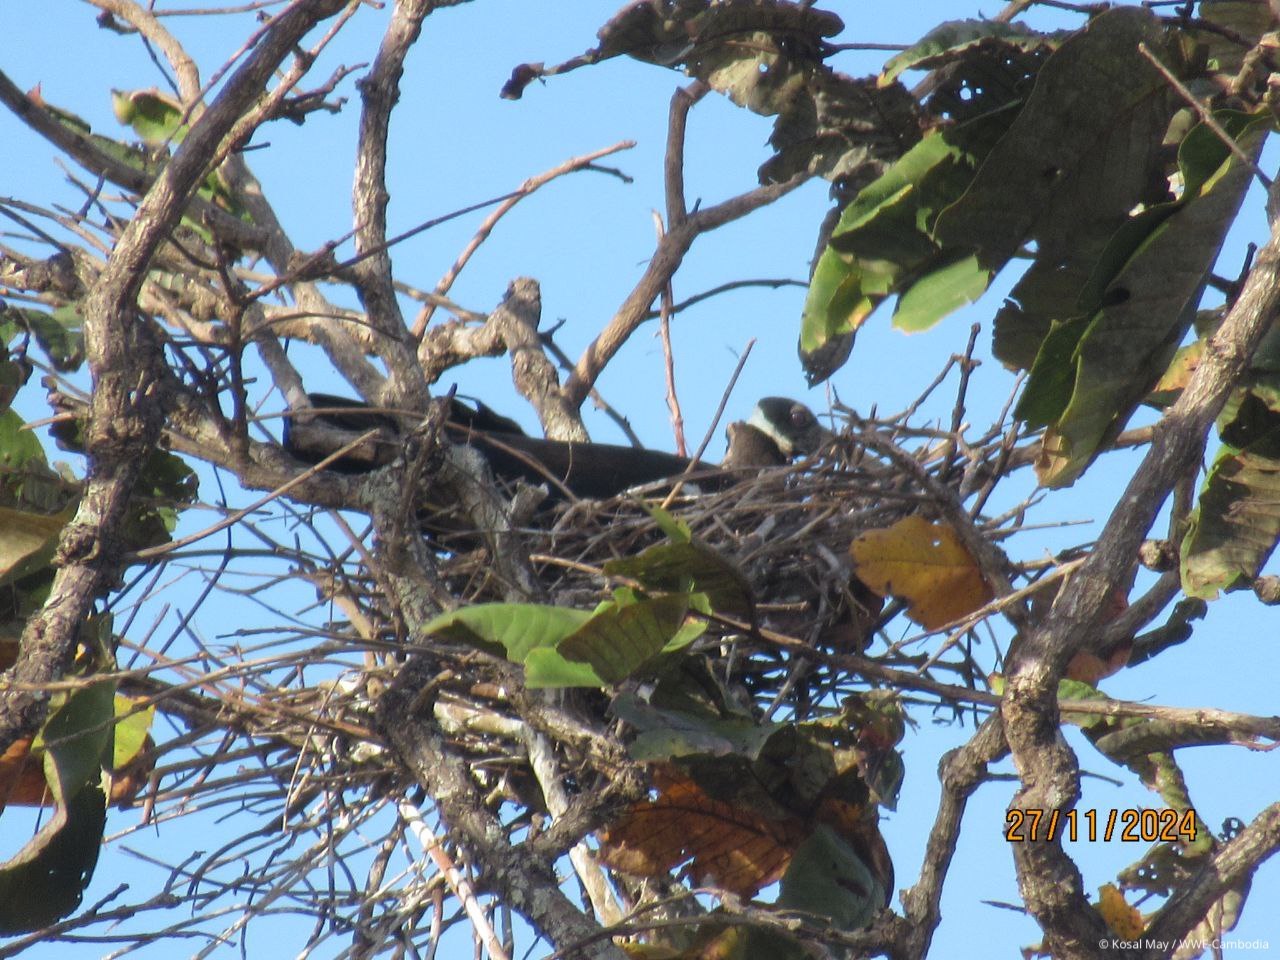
[0, 0, 1280, 959]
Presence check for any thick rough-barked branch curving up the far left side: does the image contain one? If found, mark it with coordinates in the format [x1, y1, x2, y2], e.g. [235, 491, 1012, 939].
[0, 0, 343, 748]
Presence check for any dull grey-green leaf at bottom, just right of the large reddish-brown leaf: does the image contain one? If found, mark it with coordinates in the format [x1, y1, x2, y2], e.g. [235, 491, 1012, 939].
[778, 824, 886, 931]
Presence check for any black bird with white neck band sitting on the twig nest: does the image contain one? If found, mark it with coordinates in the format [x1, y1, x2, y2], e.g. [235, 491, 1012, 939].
[284, 393, 831, 499]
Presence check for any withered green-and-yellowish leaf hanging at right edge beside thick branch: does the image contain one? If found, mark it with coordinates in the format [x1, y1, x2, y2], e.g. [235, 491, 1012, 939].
[1181, 392, 1280, 600]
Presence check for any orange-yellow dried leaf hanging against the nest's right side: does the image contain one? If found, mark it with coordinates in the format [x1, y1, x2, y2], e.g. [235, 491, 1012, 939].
[849, 517, 993, 630]
